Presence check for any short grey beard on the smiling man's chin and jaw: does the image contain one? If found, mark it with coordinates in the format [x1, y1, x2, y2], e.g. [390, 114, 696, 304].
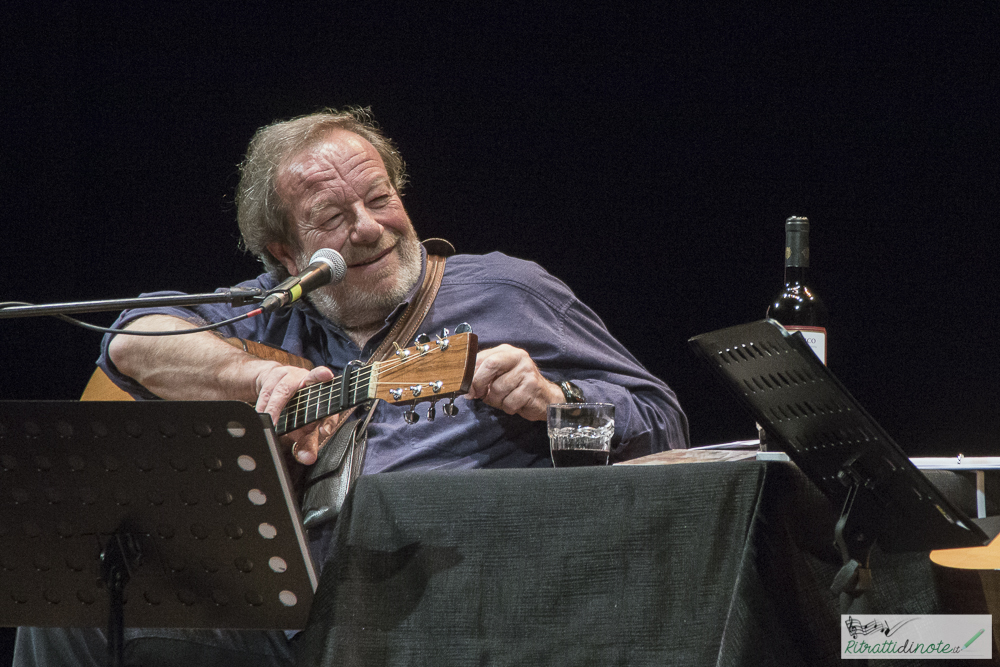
[307, 233, 420, 331]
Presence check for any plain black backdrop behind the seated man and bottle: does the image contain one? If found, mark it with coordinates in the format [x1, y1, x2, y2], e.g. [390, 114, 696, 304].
[0, 0, 1000, 656]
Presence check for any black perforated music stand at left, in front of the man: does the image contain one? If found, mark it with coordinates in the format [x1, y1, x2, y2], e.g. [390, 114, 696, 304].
[0, 401, 317, 662]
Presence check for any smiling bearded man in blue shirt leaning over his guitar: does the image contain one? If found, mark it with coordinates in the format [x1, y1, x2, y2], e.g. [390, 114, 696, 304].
[16, 110, 688, 665]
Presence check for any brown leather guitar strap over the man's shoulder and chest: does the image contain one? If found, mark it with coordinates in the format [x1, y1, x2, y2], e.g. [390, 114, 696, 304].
[350, 239, 455, 486]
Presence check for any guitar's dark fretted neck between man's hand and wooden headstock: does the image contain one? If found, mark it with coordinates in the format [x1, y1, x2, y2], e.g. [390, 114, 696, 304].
[274, 363, 378, 435]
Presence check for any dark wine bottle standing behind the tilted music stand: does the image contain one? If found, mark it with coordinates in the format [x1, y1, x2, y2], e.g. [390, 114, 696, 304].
[767, 216, 827, 364]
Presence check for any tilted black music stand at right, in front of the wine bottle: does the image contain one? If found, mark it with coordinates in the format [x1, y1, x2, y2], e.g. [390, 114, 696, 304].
[688, 319, 1000, 604]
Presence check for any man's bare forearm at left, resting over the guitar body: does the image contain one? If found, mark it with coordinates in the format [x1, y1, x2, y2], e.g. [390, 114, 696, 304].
[108, 315, 281, 403]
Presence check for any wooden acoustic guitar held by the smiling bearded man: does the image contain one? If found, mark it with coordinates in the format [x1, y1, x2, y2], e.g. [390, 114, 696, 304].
[81, 332, 479, 435]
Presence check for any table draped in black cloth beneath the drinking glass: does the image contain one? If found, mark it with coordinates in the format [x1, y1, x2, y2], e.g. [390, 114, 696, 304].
[297, 461, 986, 667]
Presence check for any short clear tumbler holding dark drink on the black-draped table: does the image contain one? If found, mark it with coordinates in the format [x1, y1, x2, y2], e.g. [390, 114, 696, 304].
[548, 403, 615, 468]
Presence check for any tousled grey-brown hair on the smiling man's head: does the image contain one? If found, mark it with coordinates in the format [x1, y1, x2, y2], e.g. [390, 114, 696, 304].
[236, 107, 406, 279]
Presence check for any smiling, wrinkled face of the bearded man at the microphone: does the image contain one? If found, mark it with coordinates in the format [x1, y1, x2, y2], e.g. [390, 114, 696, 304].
[268, 130, 420, 328]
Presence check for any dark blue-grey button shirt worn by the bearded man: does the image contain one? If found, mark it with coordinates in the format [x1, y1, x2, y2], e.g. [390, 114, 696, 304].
[98, 252, 688, 474]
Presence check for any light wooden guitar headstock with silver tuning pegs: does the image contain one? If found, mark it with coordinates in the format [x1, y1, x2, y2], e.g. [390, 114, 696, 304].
[375, 325, 479, 423]
